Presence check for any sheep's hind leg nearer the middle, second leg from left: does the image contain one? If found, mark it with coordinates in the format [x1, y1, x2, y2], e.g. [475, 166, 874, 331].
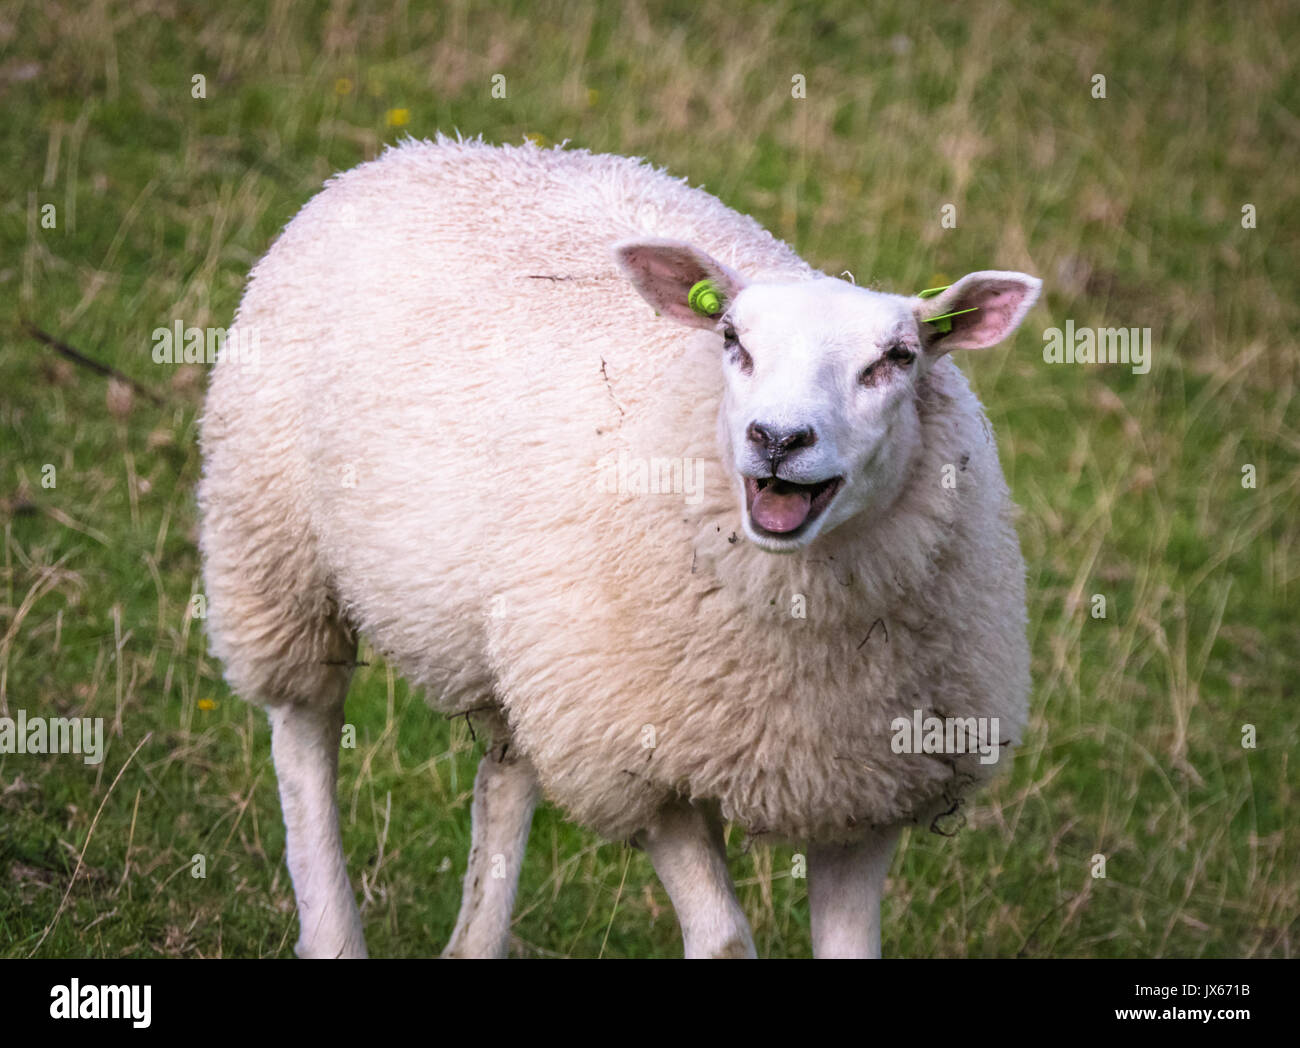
[442, 742, 538, 957]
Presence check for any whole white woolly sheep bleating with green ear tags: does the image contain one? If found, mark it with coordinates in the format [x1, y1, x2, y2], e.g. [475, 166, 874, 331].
[199, 135, 1040, 957]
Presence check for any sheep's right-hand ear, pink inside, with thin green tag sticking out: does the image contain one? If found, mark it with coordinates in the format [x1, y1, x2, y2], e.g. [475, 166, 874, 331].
[913, 269, 1043, 355]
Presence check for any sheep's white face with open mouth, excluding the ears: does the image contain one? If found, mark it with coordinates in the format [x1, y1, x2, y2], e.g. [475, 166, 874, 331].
[718, 280, 931, 551]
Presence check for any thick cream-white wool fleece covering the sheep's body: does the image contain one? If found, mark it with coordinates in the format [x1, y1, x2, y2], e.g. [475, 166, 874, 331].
[200, 138, 1028, 840]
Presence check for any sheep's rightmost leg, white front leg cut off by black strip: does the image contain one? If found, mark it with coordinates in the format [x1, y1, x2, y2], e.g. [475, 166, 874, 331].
[809, 826, 900, 957]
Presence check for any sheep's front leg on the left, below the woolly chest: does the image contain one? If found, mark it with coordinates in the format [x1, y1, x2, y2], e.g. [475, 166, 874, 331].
[641, 804, 755, 957]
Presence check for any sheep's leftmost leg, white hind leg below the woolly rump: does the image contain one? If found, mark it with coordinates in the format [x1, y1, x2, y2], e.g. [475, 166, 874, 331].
[267, 689, 365, 957]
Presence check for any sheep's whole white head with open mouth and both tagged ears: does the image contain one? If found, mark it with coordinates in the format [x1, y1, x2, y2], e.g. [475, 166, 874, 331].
[615, 239, 1041, 553]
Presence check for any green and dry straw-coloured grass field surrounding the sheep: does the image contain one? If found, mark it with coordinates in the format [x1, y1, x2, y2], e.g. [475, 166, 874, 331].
[0, 0, 1300, 957]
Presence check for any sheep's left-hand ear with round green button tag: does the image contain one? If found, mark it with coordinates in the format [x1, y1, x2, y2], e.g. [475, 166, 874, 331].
[614, 239, 745, 328]
